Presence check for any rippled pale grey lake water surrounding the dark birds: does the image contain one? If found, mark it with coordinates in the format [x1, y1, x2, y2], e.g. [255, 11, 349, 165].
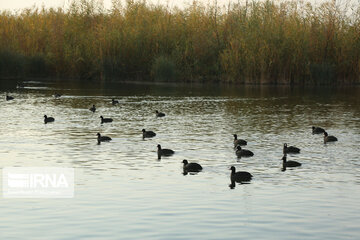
[0, 81, 360, 239]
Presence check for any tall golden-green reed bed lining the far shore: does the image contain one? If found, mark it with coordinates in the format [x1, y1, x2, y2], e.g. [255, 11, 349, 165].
[0, 0, 360, 84]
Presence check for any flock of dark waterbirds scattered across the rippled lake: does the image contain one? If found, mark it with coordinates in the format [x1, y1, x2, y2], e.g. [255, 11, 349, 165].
[6, 93, 338, 187]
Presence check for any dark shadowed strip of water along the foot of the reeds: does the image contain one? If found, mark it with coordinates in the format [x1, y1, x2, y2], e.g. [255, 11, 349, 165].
[0, 78, 360, 95]
